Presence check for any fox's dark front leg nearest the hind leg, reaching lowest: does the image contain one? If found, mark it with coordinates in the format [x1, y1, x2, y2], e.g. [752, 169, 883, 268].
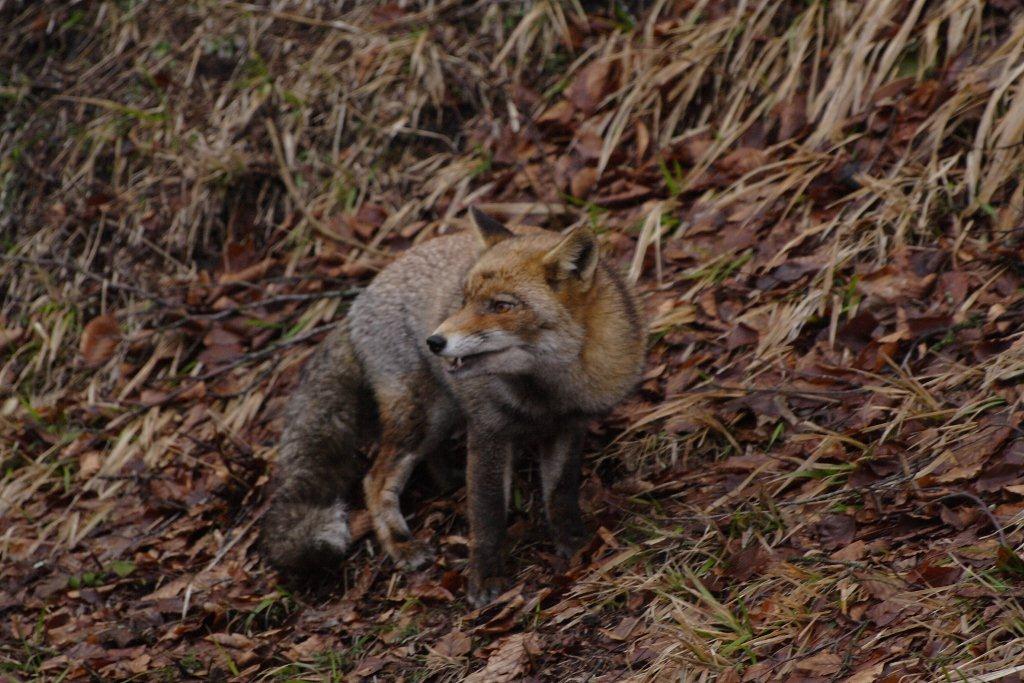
[466, 428, 513, 607]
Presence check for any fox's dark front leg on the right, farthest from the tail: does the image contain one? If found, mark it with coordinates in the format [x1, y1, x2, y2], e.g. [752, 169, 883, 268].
[541, 427, 587, 557]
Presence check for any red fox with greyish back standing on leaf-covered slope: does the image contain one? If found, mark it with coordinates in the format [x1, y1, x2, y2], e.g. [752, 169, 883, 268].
[261, 207, 646, 606]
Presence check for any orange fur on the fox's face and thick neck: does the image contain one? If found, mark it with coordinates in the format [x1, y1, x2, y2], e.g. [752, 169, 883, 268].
[436, 228, 644, 411]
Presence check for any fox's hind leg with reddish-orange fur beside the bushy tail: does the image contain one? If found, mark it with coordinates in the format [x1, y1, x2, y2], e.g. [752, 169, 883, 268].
[362, 383, 453, 568]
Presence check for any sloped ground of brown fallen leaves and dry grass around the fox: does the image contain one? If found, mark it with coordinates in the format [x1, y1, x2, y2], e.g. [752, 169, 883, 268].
[6, 0, 1024, 681]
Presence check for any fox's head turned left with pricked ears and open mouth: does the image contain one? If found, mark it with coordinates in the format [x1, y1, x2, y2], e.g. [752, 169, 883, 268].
[427, 209, 598, 377]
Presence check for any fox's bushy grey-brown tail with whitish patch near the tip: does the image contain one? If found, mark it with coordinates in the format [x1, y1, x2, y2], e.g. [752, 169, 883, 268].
[260, 322, 376, 574]
